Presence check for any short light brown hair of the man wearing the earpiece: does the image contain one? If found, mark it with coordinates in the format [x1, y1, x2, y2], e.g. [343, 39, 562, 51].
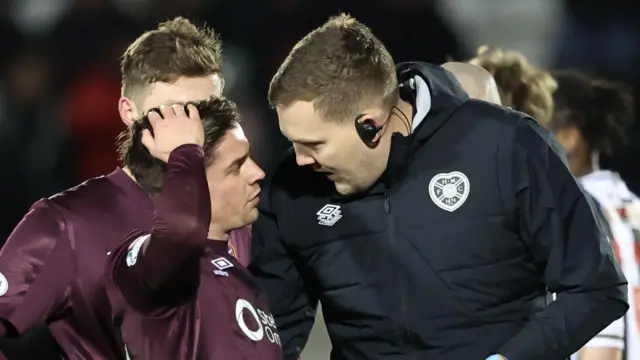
[268, 14, 398, 121]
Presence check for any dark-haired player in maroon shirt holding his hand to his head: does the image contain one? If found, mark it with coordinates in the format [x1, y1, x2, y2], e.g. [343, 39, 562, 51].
[107, 98, 282, 360]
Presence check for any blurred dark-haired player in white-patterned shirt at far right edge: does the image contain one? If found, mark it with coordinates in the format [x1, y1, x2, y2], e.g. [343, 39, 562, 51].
[544, 70, 640, 360]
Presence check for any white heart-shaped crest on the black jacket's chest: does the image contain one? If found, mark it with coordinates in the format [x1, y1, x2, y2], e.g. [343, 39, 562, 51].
[429, 171, 471, 212]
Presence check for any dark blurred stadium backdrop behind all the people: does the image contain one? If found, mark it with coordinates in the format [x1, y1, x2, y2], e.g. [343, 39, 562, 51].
[0, 0, 640, 360]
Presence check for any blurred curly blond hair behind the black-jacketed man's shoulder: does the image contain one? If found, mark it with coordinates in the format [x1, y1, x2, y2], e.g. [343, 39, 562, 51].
[469, 46, 558, 124]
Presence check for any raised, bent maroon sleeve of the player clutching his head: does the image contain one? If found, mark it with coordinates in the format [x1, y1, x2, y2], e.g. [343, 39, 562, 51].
[107, 145, 211, 316]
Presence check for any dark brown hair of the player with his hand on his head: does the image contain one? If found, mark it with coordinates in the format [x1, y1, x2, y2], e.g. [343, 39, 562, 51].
[118, 97, 240, 195]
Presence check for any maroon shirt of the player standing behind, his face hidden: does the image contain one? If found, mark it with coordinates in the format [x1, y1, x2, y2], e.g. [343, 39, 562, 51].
[0, 169, 249, 360]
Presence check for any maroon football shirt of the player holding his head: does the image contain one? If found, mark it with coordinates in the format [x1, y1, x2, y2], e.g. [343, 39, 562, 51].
[107, 145, 282, 360]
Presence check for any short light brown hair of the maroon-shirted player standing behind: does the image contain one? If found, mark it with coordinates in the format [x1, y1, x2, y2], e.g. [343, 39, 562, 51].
[120, 17, 222, 103]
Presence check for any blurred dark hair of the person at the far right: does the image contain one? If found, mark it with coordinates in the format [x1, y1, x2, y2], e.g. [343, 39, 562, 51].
[551, 70, 635, 155]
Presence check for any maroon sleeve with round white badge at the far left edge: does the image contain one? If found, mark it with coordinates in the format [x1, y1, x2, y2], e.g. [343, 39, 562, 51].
[0, 200, 73, 337]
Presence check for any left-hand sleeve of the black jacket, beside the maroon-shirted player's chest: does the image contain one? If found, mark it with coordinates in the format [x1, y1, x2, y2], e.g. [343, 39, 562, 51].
[249, 181, 318, 360]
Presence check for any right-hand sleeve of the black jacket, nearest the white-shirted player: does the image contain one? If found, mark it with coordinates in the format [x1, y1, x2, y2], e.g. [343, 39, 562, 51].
[498, 119, 629, 360]
